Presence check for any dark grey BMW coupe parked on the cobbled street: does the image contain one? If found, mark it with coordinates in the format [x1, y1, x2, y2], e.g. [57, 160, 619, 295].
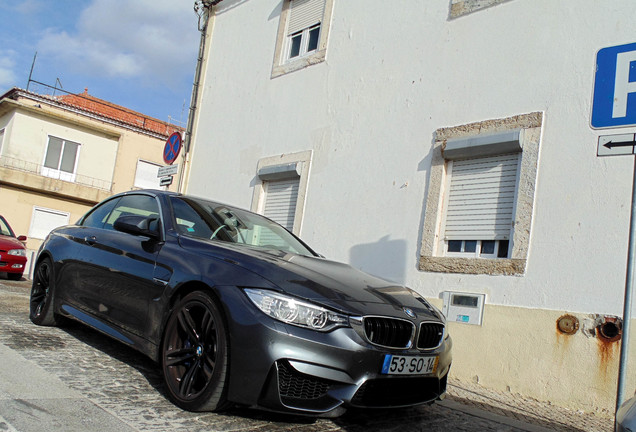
[30, 191, 452, 416]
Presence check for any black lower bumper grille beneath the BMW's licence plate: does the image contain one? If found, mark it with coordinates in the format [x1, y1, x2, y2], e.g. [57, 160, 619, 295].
[351, 376, 446, 408]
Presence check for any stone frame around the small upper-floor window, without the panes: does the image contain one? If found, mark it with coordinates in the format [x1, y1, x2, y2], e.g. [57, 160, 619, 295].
[272, 0, 335, 78]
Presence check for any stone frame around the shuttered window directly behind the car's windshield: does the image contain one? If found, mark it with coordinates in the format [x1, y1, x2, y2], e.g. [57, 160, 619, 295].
[250, 150, 313, 236]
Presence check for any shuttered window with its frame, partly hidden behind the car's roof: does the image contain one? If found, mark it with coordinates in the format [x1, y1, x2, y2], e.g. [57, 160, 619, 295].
[252, 150, 312, 235]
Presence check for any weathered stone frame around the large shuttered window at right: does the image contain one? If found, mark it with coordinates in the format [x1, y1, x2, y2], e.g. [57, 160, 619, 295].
[419, 112, 543, 276]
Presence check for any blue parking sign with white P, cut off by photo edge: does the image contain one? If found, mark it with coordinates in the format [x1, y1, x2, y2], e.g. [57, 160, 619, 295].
[591, 43, 636, 129]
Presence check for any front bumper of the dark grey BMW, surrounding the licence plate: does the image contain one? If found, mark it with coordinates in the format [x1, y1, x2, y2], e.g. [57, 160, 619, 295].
[220, 289, 452, 416]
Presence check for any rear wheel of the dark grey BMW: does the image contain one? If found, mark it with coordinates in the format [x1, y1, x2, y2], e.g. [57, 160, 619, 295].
[29, 258, 57, 326]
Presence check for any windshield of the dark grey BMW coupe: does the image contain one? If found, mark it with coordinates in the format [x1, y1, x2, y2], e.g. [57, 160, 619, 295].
[171, 197, 314, 256]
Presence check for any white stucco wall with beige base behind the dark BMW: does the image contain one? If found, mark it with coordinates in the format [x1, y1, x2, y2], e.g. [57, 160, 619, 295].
[188, 0, 636, 408]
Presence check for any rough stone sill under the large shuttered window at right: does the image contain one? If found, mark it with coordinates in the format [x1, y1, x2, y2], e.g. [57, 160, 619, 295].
[419, 256, 526, 276]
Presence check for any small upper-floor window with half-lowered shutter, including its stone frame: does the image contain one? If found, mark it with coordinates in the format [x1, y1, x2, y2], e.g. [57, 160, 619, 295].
[272, 0, 333, 77]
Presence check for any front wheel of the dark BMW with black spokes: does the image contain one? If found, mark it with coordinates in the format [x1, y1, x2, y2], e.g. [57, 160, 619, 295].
[161, 291, 229, 411]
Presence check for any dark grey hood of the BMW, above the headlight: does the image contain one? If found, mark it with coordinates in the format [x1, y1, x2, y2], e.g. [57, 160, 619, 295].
[182, 235, 442, 319]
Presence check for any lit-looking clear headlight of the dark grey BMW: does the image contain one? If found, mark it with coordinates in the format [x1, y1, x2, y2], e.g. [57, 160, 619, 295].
[244, 288, 349, 331]
